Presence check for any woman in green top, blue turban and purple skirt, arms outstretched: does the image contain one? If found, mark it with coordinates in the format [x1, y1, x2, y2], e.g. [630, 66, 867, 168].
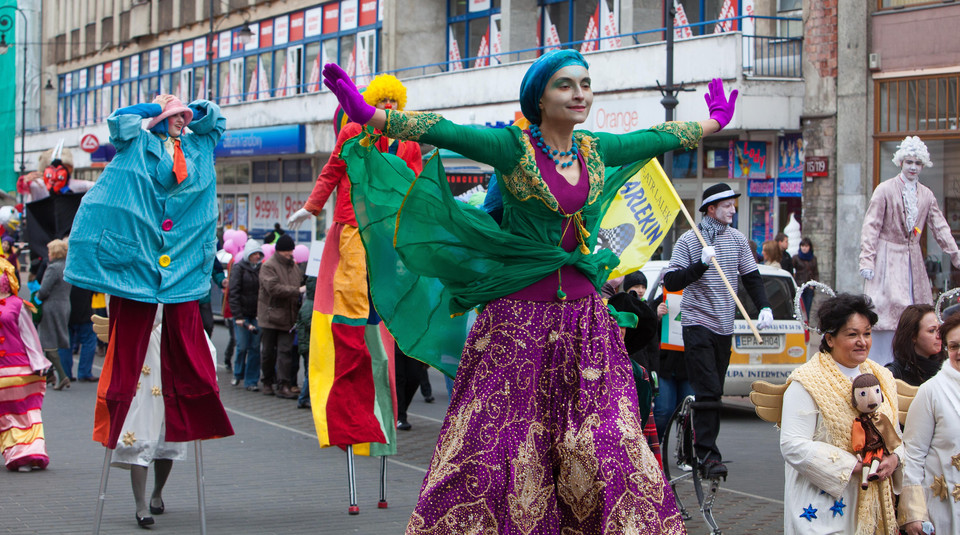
[323, 50, 736, 535]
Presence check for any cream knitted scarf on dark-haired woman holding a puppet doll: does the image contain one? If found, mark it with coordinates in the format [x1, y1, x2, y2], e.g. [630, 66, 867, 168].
[787, 353, 897, 535]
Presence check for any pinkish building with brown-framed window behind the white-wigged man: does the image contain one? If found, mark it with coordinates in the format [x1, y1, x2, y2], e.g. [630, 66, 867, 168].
[801, 0, 960, 295]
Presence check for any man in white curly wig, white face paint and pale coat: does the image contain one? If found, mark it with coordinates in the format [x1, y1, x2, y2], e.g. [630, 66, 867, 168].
[860, 136, 960, 365]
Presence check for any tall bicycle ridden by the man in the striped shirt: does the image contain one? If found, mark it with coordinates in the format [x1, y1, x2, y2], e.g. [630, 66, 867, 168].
[660, 396, 723, 535]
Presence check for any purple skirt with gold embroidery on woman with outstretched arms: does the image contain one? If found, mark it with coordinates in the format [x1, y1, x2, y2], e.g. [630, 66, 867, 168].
[406, 294, 685, 535]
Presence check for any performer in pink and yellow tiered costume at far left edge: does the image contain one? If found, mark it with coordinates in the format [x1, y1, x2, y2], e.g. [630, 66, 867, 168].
[0, 259, 50, 471]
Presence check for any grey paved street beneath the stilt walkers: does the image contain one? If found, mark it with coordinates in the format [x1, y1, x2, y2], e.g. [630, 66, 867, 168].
[0, 326, 783, 534]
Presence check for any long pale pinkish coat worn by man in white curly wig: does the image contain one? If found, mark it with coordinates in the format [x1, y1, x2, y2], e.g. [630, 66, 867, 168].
[860, 175, 960, 331]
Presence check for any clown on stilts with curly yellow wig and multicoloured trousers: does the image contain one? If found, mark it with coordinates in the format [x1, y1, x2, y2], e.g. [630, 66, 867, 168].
[287, 75, 423, 514]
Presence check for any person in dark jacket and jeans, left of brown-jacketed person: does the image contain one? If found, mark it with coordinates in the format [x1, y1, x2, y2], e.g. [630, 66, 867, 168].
[228, 238, 263, 392]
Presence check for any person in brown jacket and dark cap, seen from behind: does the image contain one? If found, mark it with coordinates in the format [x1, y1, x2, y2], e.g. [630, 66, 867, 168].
[257, 234, 304, 399]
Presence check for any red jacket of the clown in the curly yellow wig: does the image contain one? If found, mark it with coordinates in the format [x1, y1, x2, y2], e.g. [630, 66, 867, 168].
[303, 122, 423, 227]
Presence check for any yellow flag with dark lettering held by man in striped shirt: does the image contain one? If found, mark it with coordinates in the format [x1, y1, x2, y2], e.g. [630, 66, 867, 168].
[598, 159, 682, 278]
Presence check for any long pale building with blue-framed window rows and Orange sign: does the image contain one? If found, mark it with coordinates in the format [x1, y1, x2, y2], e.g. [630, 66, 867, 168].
[18, 0, 807, 245]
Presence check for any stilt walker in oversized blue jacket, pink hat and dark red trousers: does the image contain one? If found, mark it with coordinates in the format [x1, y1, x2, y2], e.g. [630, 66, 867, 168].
[66, 95, 234, 522]
